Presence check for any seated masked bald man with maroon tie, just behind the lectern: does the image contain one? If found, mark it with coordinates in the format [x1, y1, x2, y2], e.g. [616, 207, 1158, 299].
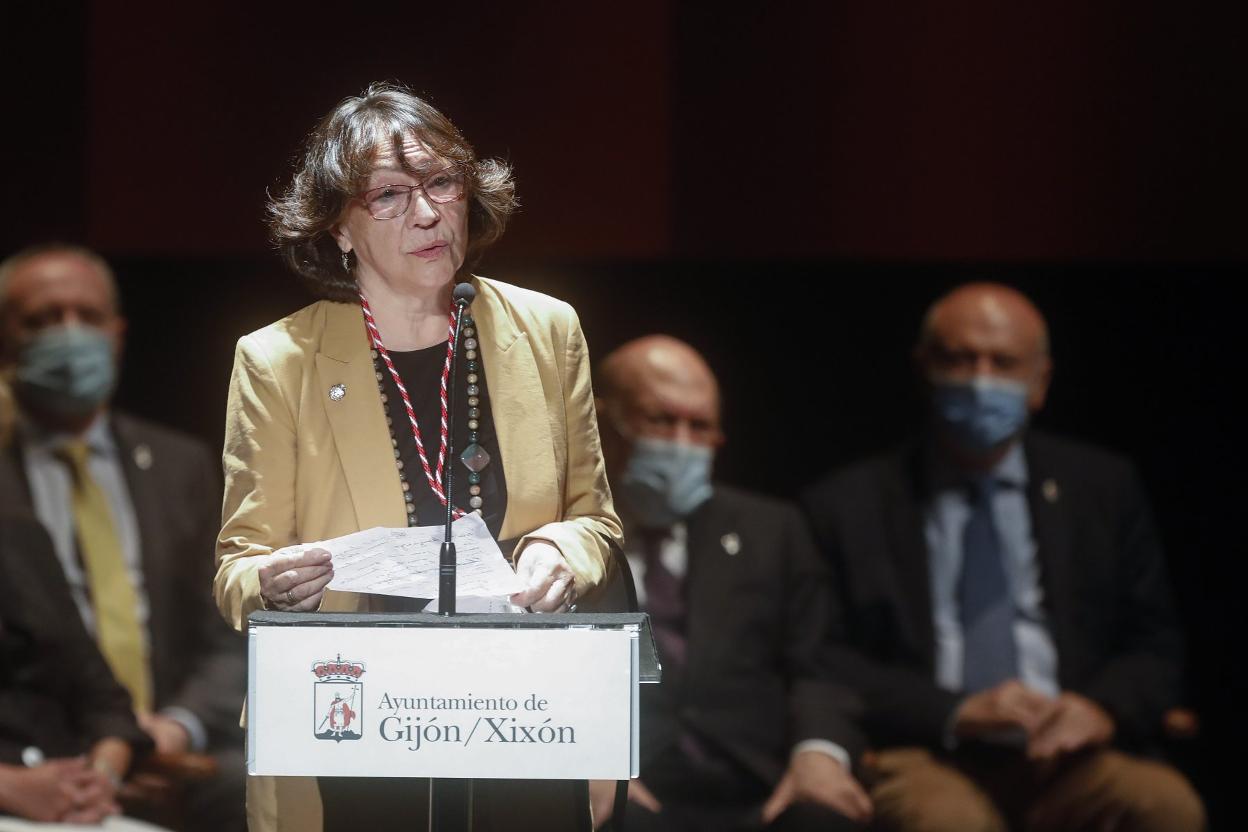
[595, 336, 871, 832]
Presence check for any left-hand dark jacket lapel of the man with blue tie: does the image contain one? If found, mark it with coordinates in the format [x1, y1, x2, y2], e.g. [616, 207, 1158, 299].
[885, 452, 936, 672]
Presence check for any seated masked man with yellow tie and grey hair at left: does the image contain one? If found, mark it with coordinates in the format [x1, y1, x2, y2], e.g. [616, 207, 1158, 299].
[0, 244, 246, 831]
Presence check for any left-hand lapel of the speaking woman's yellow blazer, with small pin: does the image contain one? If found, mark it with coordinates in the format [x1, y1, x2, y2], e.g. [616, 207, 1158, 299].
[314, 303, 404, 529]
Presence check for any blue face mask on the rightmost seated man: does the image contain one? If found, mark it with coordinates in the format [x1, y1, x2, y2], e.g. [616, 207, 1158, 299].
[932, 375, 1027, 450]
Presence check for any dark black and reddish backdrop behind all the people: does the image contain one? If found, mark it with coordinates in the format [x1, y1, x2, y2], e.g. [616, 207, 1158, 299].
[0, 0, 1248, 828]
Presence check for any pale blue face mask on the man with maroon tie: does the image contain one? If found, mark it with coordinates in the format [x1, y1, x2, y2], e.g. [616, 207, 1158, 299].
[620, 439, 715, 529]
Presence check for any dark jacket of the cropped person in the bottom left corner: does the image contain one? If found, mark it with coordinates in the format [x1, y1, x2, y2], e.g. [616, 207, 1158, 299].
[0, 513, 151, 765]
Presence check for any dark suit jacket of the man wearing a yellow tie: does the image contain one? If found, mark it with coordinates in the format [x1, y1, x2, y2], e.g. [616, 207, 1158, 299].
[0, 412, 247, 746]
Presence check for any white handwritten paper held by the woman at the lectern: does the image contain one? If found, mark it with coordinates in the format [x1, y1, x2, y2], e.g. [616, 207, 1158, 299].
[275, 514, 524, 599]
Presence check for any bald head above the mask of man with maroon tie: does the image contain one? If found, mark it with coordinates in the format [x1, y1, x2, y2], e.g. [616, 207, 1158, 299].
[595, 336, 723, 481]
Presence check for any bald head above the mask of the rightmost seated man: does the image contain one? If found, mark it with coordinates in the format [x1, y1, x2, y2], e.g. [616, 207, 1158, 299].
[915, 283, 1052, 413]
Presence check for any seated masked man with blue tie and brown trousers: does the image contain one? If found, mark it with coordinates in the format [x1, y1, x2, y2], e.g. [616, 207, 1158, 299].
[804, 284, 1204, 832]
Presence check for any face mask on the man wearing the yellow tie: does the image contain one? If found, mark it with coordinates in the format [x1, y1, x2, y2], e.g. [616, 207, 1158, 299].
[15, 327, 117, 417]
